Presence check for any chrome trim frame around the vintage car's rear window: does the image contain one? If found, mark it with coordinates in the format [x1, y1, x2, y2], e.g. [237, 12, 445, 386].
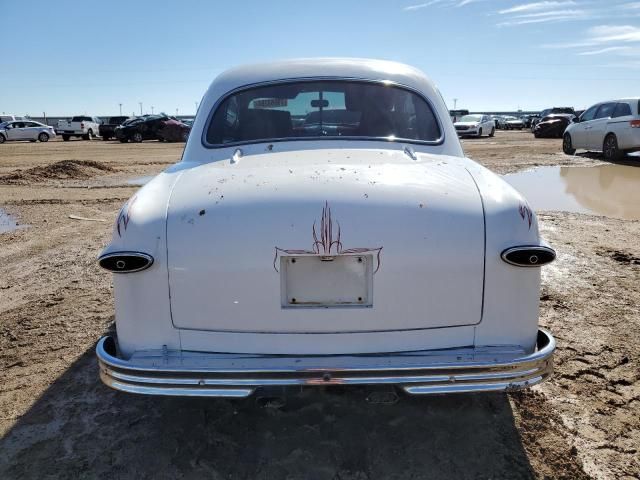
[201, 76, 445, 149]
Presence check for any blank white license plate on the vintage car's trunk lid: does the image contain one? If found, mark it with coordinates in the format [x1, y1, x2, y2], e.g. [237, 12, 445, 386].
[280, 255, 373, 308]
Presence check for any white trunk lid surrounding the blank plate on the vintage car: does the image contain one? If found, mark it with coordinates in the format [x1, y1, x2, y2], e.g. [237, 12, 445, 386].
[167, 145, 484, 340]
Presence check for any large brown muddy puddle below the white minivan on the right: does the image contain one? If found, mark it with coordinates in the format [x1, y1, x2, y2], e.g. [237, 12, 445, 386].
[504, 163, 640, 220]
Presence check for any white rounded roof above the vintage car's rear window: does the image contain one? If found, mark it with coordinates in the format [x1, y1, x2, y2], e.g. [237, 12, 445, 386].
[209, 58, 435, 97]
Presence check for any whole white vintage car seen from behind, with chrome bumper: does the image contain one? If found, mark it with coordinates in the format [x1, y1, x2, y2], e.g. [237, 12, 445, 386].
[97, 59, 555, 397]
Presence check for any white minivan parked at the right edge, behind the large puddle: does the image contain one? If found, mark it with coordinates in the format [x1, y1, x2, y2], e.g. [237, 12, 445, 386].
[562, 98, 640, 161]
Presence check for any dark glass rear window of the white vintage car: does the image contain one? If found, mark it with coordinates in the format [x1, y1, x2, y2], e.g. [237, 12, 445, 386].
[206, 80, 442, 146]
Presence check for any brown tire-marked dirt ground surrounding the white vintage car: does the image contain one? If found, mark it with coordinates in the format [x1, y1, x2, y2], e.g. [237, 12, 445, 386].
[0, 132, 640, 480]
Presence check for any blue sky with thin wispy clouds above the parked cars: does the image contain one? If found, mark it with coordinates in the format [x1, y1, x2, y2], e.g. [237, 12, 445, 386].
[0, 0, 640, 116]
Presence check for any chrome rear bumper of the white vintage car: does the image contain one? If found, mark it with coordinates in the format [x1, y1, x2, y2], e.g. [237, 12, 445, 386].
[96, 329, 556, 397]
